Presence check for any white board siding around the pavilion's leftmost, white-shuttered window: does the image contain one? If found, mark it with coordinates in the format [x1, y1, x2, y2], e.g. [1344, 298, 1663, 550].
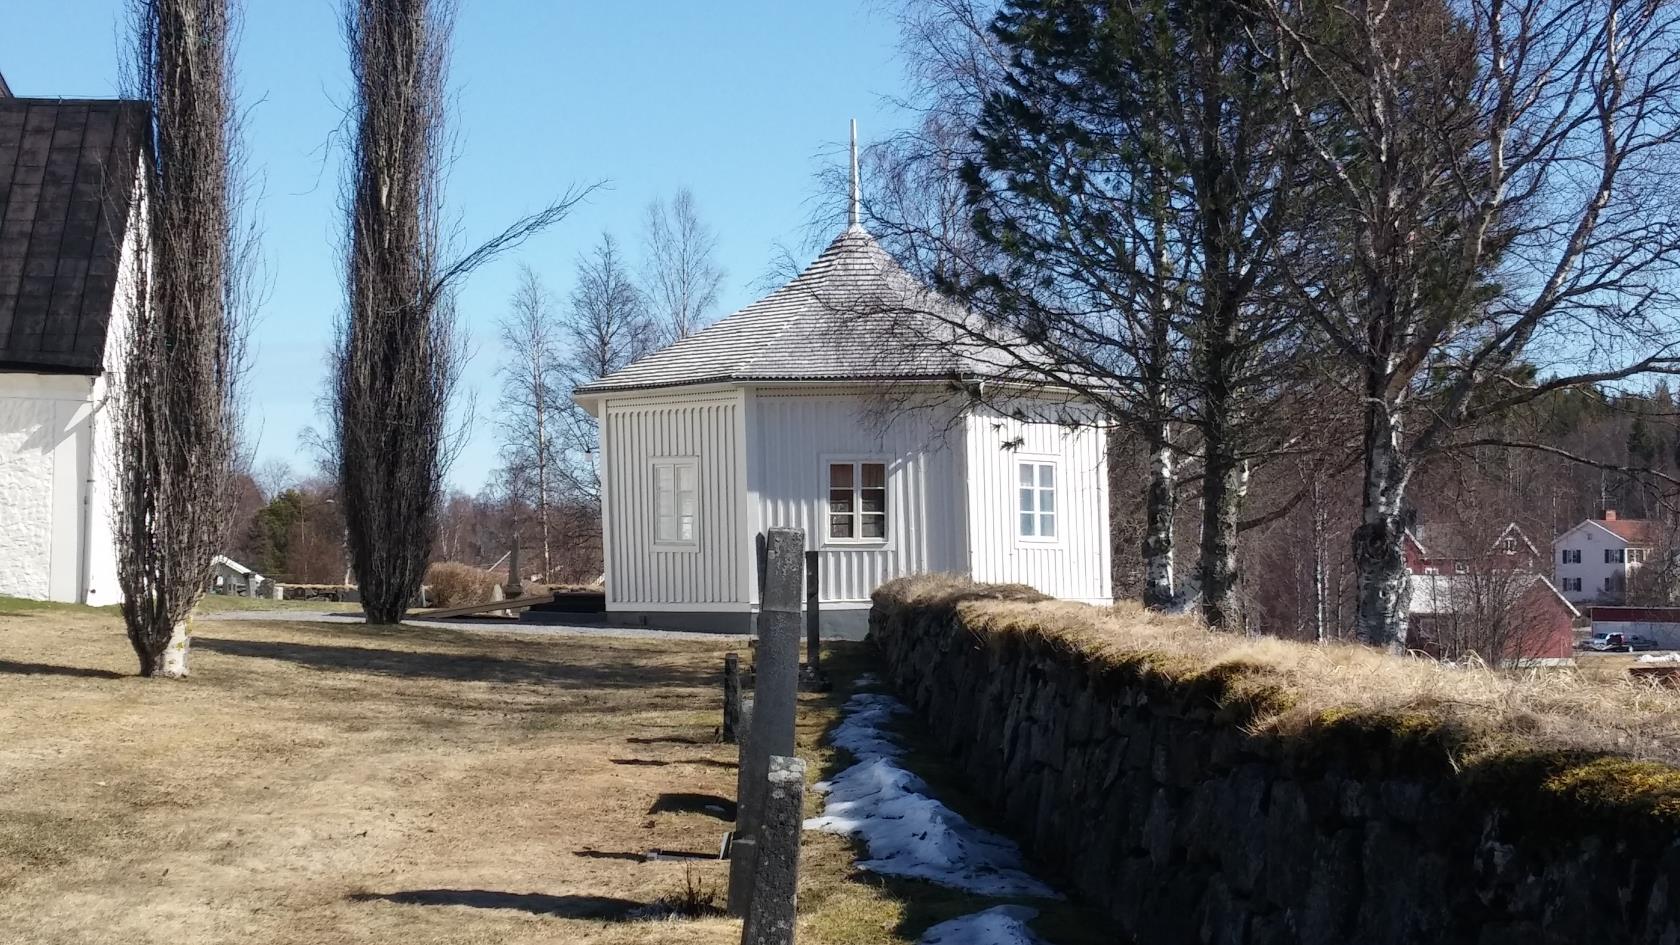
[603, 395, 748, 605]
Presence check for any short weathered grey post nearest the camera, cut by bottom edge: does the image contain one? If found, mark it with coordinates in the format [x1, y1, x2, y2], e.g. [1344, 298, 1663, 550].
[741, 755, 805, 945]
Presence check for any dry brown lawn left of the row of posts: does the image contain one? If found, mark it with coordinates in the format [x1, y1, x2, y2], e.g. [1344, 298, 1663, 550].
[0, 607, 756, 945]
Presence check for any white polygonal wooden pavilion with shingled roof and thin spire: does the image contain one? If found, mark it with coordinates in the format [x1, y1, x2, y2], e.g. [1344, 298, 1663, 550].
[575, 123, 1110, 632]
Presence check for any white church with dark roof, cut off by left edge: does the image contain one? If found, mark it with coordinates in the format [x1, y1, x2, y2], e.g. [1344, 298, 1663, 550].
[0, 82, 146, 604]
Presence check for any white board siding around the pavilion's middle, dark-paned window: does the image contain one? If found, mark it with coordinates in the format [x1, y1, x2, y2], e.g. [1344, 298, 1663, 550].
[749, 392, 968, 602]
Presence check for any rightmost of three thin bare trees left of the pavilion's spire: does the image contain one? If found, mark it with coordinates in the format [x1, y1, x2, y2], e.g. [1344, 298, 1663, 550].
[643, 187, 724, 345]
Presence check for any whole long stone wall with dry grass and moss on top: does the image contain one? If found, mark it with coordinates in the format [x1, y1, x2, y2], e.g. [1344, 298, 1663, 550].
[870, 577, 1680, 945]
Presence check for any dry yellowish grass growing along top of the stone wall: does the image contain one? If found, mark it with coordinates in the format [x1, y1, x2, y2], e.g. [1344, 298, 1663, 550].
[877, 575, 1680, 821]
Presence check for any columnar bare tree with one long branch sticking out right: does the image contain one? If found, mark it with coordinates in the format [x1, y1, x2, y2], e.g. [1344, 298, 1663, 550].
[328, 0, 583, 624]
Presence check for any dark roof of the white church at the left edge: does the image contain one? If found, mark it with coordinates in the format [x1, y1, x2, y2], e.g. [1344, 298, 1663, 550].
[0, 98, 146, 375]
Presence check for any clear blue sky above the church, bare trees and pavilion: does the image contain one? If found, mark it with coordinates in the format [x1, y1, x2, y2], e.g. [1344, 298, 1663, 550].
[0, 0, 904, 491]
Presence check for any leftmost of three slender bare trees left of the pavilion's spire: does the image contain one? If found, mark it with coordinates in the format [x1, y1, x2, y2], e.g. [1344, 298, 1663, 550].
[497, 266, 564, 580]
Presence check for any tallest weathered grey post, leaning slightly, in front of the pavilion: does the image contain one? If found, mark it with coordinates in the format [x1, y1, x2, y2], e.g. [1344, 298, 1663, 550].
[729, 528, 805, 916]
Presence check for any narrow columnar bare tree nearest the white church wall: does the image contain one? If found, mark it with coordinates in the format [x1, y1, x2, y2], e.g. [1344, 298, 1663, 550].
[113, 0, 252, 678]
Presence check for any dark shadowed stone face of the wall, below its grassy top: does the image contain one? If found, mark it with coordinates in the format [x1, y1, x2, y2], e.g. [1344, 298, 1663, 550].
[870, 583, 1680, 945]
